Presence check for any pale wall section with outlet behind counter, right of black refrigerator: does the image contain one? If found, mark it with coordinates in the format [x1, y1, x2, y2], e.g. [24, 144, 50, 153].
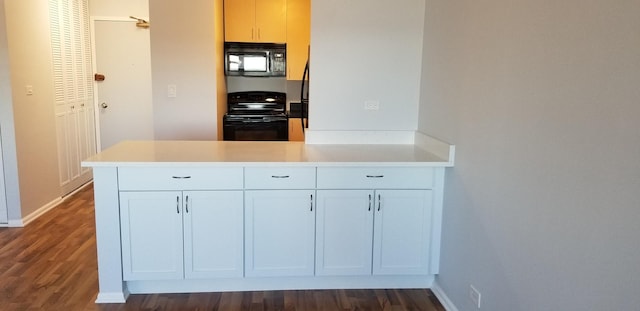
[309, 0, 424, 139]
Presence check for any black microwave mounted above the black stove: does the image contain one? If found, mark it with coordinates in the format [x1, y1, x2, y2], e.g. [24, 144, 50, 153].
[224, 42, 287, 77]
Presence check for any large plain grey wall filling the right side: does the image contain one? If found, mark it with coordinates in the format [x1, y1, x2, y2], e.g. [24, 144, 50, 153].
[419, 0, 640, 311]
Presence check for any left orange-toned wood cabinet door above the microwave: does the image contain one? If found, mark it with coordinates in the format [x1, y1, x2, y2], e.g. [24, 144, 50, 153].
[224, 0, 257, 42]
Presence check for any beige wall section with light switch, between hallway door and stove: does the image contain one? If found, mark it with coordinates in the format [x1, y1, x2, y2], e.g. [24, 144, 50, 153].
[149, 0, 219, 140]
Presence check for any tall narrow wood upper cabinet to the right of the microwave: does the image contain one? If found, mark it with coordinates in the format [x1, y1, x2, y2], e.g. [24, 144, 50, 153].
[287, 0, 311, 80]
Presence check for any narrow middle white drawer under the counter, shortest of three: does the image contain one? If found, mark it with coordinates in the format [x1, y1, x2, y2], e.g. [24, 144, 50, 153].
[244, 167, 316, 189]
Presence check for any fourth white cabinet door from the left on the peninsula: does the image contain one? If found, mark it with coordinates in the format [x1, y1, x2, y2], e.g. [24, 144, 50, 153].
[316, 190, 374, 275]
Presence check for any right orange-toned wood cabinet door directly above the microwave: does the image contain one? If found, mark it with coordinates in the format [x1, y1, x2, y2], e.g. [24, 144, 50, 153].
[255, 0, 287, 43]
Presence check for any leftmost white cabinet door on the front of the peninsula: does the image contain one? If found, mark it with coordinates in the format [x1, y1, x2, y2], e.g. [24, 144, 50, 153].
[120, 191, 183, 281]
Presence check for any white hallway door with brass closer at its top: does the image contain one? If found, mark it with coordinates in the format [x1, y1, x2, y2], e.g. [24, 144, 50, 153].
[92, 17, 153, 150]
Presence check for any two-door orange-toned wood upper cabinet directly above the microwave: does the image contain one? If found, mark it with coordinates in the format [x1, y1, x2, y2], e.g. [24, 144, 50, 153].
[224, 0, 287, 43]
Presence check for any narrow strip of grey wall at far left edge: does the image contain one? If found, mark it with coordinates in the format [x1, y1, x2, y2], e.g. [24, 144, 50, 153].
[0, 0, 21, 224]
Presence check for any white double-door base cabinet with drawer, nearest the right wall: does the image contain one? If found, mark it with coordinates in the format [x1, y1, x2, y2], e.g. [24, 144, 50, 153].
[316, 167, 437, 275]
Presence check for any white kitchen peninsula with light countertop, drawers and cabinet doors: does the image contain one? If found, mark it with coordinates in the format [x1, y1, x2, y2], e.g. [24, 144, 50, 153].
[83, 138, 453, 303]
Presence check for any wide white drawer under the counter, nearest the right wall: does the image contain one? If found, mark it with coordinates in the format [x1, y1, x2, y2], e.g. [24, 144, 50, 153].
[318, 167, 434, 189]
